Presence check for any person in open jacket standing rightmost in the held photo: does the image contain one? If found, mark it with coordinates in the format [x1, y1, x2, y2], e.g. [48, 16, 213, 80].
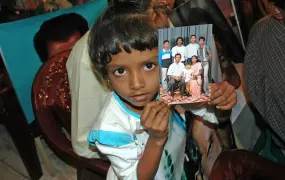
[197, 36, 211, 96]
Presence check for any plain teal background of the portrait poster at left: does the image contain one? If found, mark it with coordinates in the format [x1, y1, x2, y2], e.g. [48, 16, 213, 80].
[0, 0, 108, 123]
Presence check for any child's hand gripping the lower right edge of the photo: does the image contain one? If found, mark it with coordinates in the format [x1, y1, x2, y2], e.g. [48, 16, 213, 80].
[209, 81, 237, 110]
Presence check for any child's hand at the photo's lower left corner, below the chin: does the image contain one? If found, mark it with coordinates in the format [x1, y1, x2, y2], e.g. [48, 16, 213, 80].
[141, 101, 170, 143]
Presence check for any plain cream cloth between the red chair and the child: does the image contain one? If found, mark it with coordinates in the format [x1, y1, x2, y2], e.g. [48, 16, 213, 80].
[66, 31, 110, 158]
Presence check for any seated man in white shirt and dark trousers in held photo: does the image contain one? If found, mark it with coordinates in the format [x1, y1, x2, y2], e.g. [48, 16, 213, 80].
[167, 53, 185, 99]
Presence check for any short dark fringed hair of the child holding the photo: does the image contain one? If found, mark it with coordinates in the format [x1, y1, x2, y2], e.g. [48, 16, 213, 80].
[89, 0, 158, 78]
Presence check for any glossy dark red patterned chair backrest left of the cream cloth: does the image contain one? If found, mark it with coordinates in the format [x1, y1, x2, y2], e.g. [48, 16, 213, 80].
[32, 50, 71, 132]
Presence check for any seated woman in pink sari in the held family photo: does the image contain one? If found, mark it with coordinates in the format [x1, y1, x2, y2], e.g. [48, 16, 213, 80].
[190, 56, 203, 99]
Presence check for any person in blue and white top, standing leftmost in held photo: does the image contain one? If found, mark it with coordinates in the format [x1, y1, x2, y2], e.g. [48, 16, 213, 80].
[158, 40, 172, 91]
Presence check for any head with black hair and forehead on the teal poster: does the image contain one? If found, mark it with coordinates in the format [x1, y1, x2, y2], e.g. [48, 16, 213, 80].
[34, 13, 88, 63]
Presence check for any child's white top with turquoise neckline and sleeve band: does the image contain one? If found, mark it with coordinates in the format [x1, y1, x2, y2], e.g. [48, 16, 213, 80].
[88, 92, 186, 180]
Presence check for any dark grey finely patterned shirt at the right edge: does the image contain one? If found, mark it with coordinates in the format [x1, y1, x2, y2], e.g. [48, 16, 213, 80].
[244, 17, 285, 148]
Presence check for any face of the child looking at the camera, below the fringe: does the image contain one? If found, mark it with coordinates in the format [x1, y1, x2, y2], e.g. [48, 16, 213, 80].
[107, 49, 159, 107]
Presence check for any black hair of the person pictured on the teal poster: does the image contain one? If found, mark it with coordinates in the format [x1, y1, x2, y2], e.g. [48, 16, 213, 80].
[34, 13, 88, 62]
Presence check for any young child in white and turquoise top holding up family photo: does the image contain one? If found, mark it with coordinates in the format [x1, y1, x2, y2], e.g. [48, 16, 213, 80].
[88, 3, 219, 180]
